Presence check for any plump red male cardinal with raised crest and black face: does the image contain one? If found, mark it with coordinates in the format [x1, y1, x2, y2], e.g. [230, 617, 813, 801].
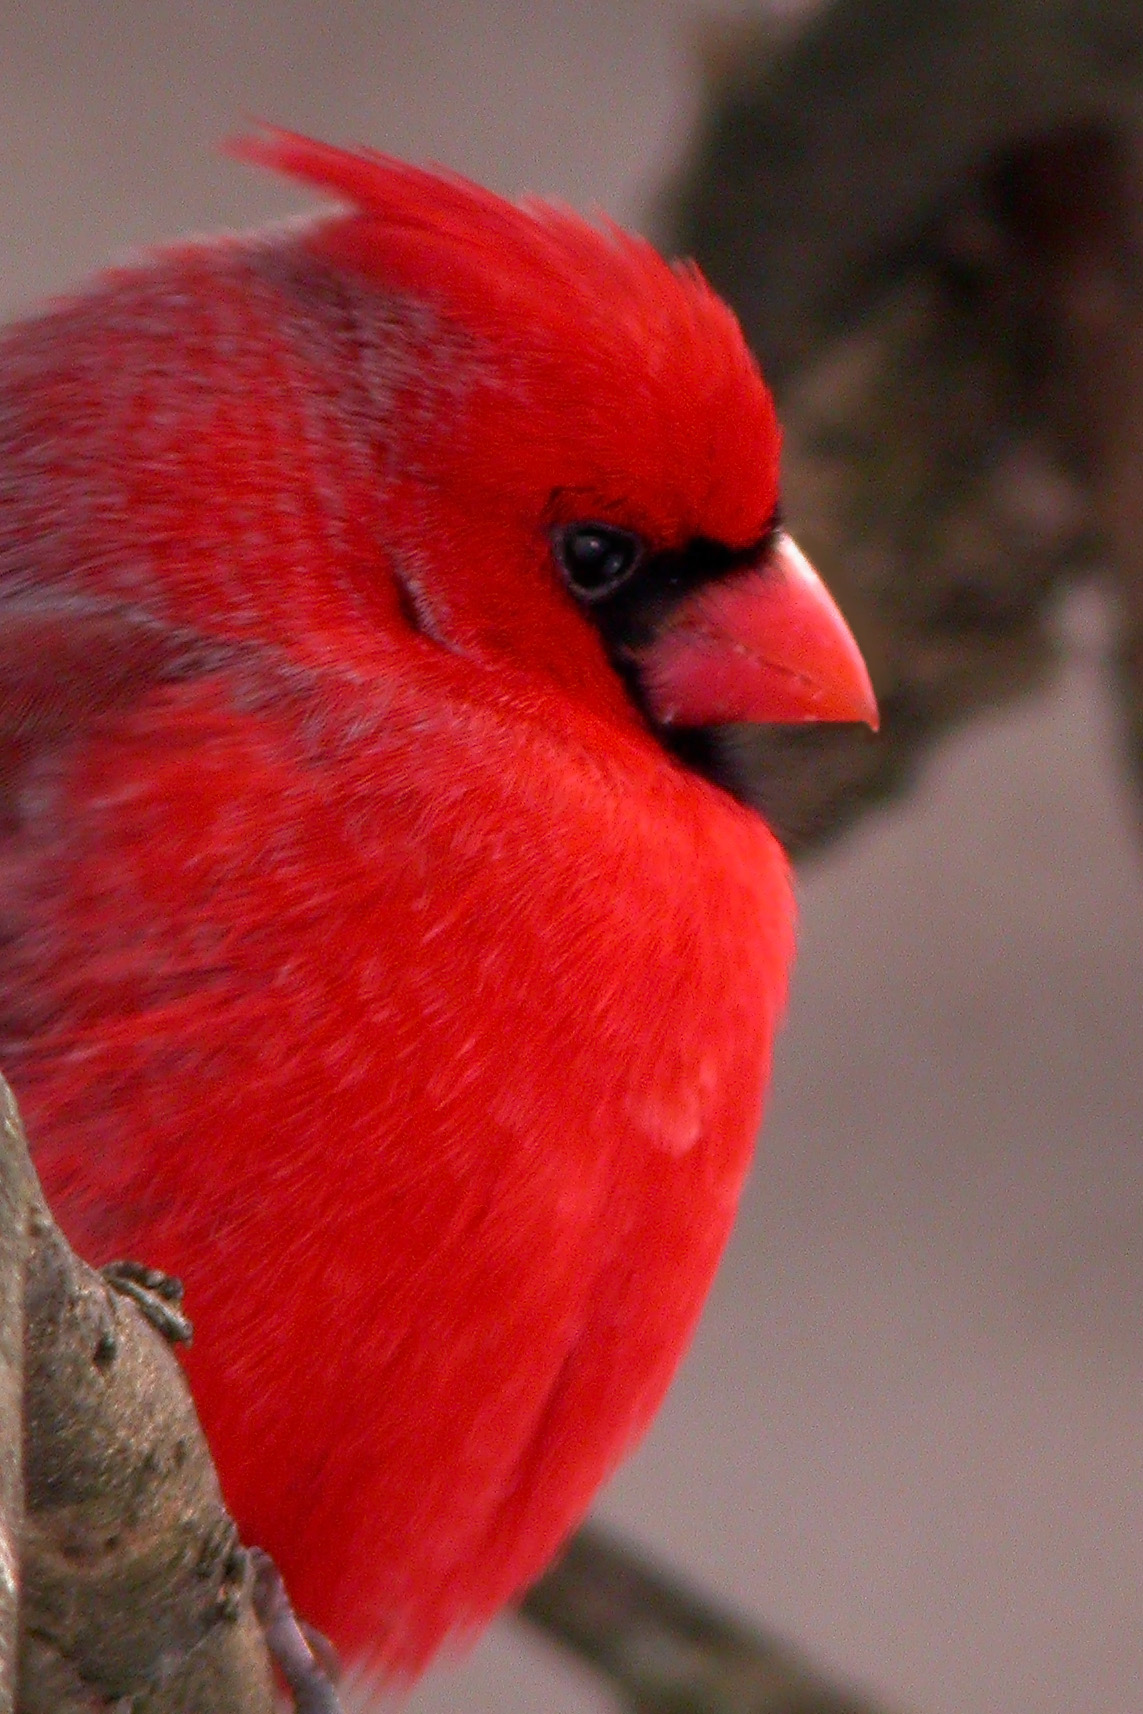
[0, 132, 876, 1673]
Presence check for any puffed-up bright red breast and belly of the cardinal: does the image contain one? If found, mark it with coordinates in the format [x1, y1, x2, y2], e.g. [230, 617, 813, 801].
[5, 661, 792, 1666]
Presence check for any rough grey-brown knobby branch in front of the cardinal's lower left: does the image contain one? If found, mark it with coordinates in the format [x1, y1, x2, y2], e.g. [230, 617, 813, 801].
[0, 1080, 274, 1714]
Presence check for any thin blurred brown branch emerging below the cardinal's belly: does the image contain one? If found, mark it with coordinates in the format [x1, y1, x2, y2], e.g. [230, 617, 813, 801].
[523, 1529, 874, 1714]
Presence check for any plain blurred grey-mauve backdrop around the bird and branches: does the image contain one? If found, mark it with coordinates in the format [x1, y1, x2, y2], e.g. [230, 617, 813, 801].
[0, 0, 1143, 1714]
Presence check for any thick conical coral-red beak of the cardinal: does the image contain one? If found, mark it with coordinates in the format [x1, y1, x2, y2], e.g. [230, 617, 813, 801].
[637, 535, 881, 732]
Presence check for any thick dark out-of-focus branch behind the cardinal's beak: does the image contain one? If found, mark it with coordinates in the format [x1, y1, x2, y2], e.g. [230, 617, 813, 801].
[665, 0, 1143, 850]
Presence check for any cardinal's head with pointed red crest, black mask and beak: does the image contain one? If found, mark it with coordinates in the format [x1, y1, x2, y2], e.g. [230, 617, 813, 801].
[231, 130, 877, 764]
